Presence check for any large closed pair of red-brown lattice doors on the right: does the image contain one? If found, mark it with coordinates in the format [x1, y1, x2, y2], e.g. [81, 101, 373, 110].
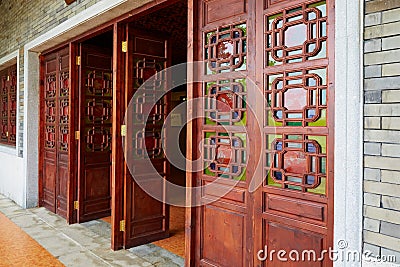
[192, 0, 334, 267]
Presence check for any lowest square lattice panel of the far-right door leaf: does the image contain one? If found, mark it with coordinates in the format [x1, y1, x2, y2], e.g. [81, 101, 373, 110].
[266, 135, 327, 194]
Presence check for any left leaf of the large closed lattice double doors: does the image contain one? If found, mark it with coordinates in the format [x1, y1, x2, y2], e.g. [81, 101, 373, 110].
[194, 0, 251, 267]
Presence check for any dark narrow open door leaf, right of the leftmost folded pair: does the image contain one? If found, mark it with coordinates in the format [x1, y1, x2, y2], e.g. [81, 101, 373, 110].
[77, 44, 113, 222]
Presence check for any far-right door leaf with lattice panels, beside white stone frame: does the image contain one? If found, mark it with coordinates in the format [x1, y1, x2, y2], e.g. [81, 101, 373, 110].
[255, 0, 334, 266]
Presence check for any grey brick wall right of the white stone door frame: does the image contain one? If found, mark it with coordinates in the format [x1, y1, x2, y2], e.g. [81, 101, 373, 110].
[363, 0, 400, 263]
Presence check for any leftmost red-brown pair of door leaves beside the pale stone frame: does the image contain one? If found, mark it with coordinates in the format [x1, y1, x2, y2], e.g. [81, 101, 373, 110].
[39, 47, 73, 221]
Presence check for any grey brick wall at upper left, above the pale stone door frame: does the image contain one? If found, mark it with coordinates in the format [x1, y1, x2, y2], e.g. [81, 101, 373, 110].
[0, 0, 101, 156]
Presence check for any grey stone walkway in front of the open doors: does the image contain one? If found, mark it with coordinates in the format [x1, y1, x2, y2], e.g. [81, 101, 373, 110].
[0, 195, 184, 267]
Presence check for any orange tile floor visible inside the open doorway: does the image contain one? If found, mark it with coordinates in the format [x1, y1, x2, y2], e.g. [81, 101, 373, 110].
[153, 206, 185, 258]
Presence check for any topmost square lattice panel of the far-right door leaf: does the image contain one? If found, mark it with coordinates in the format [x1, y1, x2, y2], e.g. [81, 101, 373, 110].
[265, 1, 327, 66]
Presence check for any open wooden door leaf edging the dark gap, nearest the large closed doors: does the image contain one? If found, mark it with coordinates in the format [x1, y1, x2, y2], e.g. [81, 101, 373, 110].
[124, 29, 170, 248]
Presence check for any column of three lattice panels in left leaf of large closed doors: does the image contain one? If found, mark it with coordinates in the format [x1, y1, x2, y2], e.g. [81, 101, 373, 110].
[203, 21, 247, 181]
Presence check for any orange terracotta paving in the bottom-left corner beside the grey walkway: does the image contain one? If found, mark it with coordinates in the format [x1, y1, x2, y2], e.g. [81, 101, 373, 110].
[0, 213, 64, 267]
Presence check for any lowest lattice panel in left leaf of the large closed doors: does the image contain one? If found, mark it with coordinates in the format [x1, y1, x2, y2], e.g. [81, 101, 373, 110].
[203, 132, 247, 180]
